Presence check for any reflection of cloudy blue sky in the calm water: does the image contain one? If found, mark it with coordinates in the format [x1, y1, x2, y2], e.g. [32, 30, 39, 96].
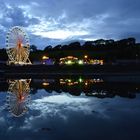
[0, 90, 140, 140]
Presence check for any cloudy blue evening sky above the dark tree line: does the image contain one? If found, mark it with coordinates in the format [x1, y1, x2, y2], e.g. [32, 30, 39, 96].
[0, 0, 140, 49]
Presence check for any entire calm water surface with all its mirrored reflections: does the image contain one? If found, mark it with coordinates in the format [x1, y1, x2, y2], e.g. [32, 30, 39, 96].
[0, 77, 140, 140]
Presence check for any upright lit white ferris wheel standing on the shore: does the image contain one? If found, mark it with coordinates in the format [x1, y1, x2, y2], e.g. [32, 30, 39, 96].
[6, 26, 31, 65]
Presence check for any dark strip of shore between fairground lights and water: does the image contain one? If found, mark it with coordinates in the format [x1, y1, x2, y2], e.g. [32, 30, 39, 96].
[0, 64, 140, 78]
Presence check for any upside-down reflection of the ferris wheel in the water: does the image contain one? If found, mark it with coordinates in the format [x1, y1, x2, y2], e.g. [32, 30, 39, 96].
[7, 80, 31, 117]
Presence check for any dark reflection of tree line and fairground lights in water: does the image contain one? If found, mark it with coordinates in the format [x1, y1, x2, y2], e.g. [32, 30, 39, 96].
[25, 76, 137, 98]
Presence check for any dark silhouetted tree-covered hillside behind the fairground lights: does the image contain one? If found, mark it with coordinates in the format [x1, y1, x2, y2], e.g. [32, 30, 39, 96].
[0, 38, 140, 61]
